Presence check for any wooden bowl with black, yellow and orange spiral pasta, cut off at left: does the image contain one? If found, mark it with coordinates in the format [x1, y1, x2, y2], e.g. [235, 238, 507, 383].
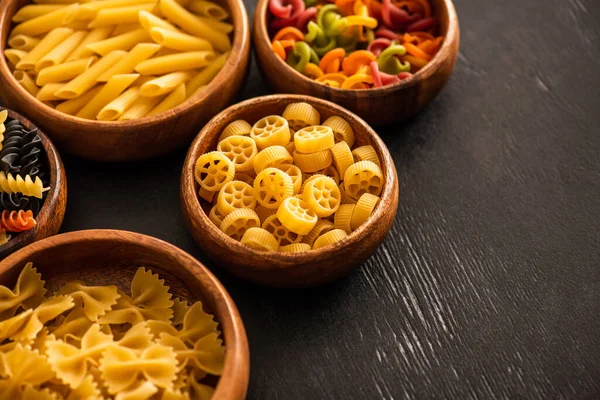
[0, 107, 67, 259]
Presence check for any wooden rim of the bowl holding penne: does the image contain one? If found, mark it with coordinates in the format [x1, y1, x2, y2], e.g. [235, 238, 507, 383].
[0, 0, 250, 126]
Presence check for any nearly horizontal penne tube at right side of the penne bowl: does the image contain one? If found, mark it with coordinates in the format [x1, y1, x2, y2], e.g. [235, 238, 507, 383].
[135, 51, 217, 75]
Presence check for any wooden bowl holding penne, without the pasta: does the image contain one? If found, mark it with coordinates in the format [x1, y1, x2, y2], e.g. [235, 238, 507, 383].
[0, 0, 250, 161]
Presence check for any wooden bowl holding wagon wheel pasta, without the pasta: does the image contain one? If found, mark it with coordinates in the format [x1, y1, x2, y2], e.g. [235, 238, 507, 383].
[181, 95, 398, 287]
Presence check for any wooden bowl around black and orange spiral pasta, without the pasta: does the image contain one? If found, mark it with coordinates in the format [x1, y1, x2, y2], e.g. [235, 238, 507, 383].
[0, 107, 67, 259]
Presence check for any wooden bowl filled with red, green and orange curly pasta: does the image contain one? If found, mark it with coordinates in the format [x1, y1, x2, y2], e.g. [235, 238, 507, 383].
[252, 0, 459, 125]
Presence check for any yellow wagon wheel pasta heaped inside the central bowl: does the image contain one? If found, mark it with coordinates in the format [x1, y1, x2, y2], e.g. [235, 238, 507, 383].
[194, 101, 384, 253]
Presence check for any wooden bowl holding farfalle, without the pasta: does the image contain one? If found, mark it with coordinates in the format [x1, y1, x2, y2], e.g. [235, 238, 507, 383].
[0, 230, 250, 400]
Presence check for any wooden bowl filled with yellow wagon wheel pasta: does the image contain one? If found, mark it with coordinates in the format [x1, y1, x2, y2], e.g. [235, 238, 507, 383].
[181, 95, 398, 287]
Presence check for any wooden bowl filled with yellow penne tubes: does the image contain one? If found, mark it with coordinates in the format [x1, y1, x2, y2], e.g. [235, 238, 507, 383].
[0, 0, 250, 161]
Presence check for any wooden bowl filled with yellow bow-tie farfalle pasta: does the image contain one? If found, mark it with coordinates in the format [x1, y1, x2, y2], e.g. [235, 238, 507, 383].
[0, 230, 249, 400]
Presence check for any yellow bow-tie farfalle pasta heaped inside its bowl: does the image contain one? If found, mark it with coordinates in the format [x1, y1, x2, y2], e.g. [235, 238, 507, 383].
[0, 263, 225, 400]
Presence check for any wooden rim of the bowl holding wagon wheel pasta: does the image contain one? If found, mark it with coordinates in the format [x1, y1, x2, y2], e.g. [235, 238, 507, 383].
[181, 94, 398, 268]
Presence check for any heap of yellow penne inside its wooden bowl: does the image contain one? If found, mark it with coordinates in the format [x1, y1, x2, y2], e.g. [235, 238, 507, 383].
[4, 0, 233, 121]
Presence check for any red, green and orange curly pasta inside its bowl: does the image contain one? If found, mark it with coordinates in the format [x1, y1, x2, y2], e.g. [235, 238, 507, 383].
[268, 0, 444, 88]
